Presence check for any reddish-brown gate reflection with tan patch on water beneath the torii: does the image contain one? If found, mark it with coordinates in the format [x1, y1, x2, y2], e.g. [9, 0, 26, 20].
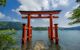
[21, 40, 60, 50]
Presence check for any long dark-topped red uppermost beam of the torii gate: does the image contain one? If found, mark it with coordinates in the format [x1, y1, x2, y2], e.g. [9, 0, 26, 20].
[20, 10, 61, 14]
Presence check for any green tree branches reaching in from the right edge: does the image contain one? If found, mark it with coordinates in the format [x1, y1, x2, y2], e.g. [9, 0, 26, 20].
[69, 0, 80, 25]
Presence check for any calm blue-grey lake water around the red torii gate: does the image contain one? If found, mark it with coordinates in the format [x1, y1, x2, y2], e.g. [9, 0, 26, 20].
[15, 30, 80, 50]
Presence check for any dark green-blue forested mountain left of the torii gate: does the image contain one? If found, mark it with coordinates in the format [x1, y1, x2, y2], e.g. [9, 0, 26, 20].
[0, 21, 22, 30]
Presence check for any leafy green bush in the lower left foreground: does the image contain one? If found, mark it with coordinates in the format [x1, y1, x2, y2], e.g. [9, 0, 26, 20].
[0, 30, 16, 50]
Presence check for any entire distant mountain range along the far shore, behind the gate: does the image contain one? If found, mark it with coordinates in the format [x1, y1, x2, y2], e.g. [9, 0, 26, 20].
[0, 21, 80, 30]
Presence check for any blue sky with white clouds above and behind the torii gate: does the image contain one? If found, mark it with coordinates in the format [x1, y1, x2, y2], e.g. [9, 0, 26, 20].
[0, 0, 80, 27]
